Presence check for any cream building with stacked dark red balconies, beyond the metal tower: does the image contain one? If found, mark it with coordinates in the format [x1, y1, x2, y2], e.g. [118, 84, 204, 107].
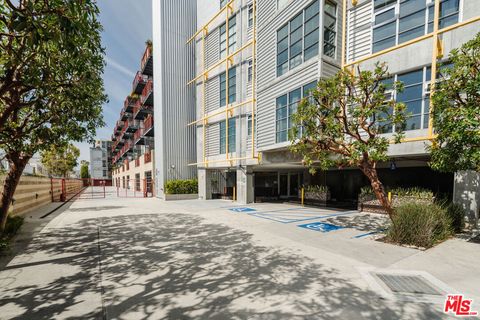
[111, 43, 155, 192]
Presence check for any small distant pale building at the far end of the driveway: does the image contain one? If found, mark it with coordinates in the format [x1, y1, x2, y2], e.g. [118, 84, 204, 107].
[90, 140, 112, 180]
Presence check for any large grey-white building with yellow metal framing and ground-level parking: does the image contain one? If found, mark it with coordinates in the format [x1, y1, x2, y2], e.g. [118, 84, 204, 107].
[187, 0, 480, 221]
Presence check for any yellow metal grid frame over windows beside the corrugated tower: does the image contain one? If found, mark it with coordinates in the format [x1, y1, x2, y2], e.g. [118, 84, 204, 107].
[187, 0, 259, 167]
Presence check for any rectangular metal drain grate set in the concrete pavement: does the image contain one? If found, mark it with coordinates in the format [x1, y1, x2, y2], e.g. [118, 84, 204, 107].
[375, 273, 443, 296]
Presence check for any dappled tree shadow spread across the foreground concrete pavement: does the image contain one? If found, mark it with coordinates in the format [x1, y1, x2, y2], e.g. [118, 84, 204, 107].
[0, 214, 442, 320]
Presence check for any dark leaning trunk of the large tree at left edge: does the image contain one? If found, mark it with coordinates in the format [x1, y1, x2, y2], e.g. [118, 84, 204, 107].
[0, 155, 31, 234]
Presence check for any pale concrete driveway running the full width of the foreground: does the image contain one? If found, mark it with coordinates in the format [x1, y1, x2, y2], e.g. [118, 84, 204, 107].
[0, 198, 480, 319]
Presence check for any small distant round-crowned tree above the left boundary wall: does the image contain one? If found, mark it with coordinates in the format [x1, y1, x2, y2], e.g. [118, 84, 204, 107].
[41, 144, 80, 178]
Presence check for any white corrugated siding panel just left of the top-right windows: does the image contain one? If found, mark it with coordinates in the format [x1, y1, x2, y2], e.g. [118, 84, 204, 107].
[347, 1, 372, 61]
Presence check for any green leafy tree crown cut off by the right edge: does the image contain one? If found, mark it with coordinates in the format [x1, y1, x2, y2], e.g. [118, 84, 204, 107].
[430, 33, 480, 172]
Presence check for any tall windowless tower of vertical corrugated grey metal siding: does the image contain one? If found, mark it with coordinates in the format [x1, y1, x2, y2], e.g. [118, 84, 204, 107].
[153, 0, 196, 194]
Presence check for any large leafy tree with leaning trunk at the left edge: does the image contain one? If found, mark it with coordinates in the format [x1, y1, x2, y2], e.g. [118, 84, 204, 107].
[0, 0, 106, 233]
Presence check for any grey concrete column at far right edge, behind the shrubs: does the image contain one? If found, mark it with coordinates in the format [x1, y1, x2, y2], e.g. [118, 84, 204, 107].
[453, 171, 480, 225]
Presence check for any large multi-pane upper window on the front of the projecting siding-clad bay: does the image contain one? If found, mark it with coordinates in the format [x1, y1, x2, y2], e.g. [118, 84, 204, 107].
[277, 0, 320, 76]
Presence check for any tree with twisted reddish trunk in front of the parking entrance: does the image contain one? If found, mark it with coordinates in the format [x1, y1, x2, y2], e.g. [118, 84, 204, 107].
[290, 64, 406, 218]
